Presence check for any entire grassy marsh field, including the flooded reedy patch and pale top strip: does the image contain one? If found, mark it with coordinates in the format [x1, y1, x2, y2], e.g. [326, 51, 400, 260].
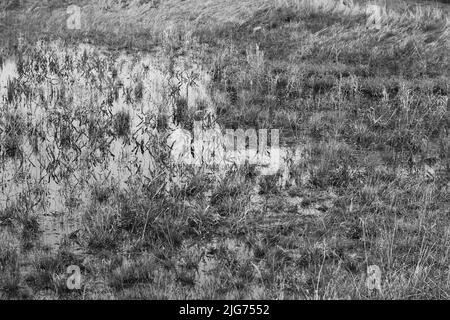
[0, 0, 450, 299]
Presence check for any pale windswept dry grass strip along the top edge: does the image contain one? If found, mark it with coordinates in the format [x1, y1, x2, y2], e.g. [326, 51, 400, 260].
[3, 0, 448, 49]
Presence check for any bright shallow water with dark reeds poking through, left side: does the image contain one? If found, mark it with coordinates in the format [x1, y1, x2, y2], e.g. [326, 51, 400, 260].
[0, 42, 301, 248]
